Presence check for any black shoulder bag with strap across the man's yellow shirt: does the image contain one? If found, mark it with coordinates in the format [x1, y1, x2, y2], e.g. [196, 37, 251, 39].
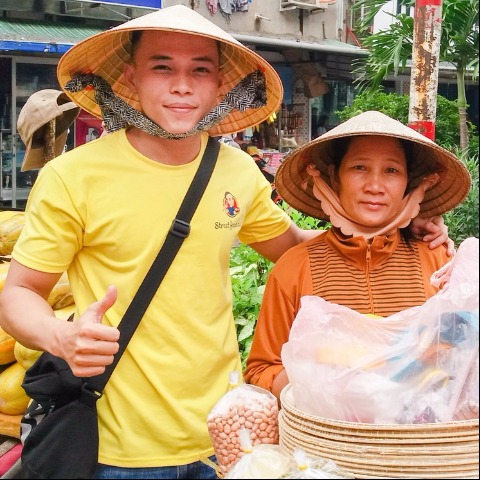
[21, 138, 219, 479]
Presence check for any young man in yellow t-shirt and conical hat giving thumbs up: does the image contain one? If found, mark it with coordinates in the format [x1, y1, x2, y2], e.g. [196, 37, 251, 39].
[0, 6, 447, 478]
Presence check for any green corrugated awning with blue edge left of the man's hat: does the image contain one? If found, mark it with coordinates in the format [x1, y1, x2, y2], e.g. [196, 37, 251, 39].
[0, 18, 105, 54]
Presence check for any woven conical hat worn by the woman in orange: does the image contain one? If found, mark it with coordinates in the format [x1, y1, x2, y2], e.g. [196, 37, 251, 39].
[275, 111, 471, 220]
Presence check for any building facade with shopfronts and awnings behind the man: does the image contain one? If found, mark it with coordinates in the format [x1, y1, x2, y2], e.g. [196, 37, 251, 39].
[0, 0, 478, 208]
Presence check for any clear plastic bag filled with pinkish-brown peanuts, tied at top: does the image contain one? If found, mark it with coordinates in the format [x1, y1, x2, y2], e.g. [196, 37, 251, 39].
[207, 372, 279, 476]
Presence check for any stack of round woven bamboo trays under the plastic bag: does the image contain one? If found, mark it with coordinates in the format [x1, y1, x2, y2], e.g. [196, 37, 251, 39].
[278, 385, 479, 478]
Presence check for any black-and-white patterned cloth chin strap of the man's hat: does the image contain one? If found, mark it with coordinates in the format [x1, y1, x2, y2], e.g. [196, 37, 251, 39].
[65, 70, 267, 140]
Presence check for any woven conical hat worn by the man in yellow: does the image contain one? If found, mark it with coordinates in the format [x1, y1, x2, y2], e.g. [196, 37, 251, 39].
[57, 5, 283, 136]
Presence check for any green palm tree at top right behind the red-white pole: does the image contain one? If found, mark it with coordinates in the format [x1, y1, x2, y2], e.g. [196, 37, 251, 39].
[353, 0, 479, 151]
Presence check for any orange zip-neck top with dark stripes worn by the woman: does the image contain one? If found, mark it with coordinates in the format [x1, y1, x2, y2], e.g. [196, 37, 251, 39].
[244, 228, 450, 390]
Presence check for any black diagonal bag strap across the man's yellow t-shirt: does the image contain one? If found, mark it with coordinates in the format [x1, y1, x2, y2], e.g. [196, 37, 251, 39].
[87, 137, 220, 394]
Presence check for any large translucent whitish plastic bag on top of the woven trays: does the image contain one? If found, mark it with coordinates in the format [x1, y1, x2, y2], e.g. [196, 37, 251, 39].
[282, 238, 479, 423]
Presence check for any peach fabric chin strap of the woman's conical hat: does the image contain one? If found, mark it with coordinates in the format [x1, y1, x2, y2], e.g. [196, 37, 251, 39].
[313, 173, 440, 240]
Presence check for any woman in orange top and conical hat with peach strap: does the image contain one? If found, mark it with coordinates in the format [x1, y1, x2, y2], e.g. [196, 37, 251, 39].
[245, 112, 470, 398]
